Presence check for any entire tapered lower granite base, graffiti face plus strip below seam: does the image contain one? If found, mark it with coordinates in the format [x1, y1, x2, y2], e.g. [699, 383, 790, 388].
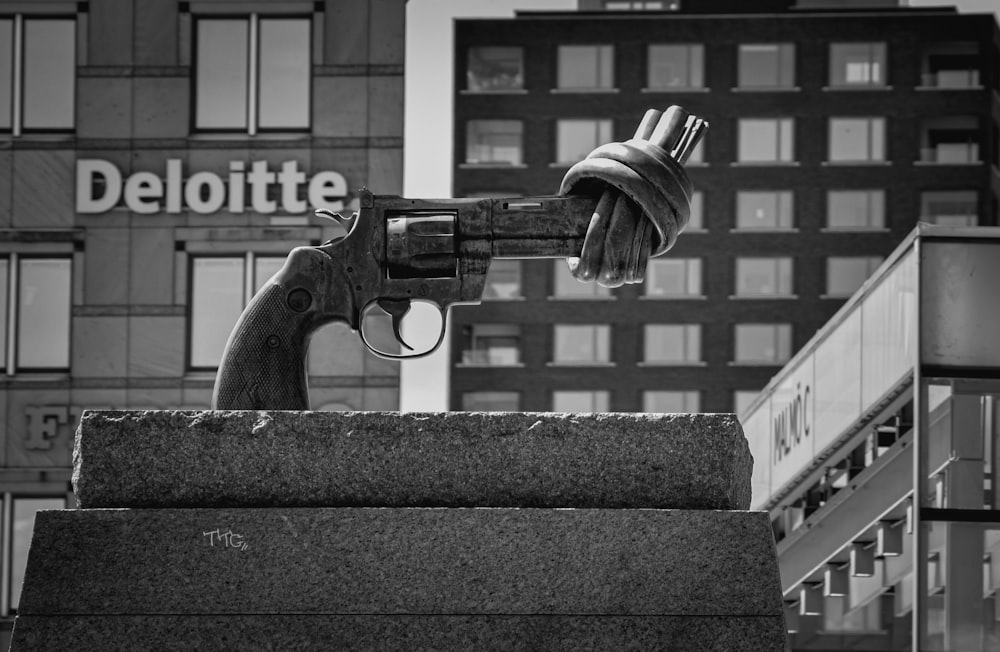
[11, 508, 785, 652]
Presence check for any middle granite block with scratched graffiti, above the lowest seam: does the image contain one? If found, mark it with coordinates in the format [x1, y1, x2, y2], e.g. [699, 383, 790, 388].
[18, 508, 783, 616]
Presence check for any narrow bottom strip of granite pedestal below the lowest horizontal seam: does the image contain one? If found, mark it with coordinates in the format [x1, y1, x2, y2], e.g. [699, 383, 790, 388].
[11, 615, 785, 652]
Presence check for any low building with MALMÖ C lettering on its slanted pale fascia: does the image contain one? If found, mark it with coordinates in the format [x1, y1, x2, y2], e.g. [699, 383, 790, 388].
[740, 224, 1000, 652]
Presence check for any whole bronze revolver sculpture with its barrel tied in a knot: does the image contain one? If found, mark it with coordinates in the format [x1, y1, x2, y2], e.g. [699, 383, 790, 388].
[212, 106, 708, 410]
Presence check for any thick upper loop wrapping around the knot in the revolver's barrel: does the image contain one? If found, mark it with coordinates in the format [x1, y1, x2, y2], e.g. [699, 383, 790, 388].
[559, 139, 693, 256]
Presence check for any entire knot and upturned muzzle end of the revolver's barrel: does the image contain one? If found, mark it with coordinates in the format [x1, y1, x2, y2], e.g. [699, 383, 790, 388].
[559, 106, 708, 287]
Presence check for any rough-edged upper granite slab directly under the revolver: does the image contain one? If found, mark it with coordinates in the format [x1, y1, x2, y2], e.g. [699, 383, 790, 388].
[73, 411, 753, 509]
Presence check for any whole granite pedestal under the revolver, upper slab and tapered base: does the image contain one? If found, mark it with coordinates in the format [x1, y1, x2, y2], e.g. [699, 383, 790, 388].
[11, 412, 785, 651]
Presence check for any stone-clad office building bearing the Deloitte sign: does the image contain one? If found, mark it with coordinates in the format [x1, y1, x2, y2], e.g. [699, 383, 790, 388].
[0, 0, 405, 647]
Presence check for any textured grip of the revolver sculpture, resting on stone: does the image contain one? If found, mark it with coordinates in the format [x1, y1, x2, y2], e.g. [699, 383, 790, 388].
[212, 284, 311, 410]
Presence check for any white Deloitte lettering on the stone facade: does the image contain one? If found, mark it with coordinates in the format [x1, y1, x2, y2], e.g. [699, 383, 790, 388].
[76, 159, 347, 215]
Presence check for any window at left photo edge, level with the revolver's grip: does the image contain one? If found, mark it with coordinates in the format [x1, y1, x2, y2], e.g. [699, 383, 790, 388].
[0, 254, 73, 374]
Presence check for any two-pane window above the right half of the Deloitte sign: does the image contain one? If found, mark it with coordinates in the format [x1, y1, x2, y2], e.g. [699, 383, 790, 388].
[194, 14, 312, 135]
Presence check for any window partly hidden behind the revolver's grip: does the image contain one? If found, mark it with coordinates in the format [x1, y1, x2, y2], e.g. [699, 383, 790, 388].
[189, 253, 285, 369]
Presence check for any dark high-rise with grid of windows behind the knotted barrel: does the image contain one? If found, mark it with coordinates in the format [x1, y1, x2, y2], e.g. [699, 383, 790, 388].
[450, 0, 1000, 412]
